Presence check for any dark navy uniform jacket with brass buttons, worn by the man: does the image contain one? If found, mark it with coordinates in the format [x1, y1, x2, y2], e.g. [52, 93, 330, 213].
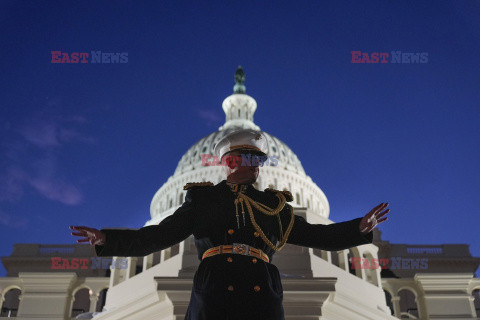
[95, 180, 373, 320]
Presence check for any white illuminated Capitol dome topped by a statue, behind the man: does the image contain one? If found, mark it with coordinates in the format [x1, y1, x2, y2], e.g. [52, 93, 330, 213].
[146, 66, 329, 225]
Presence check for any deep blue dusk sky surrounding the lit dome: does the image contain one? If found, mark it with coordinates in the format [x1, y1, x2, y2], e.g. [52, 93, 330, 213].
[0, 0, 480, 276]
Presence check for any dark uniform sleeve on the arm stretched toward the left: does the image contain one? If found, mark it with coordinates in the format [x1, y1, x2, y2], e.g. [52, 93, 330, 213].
[95, 190, 196, 257]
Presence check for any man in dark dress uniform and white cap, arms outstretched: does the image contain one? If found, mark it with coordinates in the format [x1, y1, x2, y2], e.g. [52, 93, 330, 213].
[70, 129, 390, 320]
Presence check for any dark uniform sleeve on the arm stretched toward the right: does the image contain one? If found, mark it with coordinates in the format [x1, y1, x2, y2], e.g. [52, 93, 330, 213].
[280, 205, 373, 251]
